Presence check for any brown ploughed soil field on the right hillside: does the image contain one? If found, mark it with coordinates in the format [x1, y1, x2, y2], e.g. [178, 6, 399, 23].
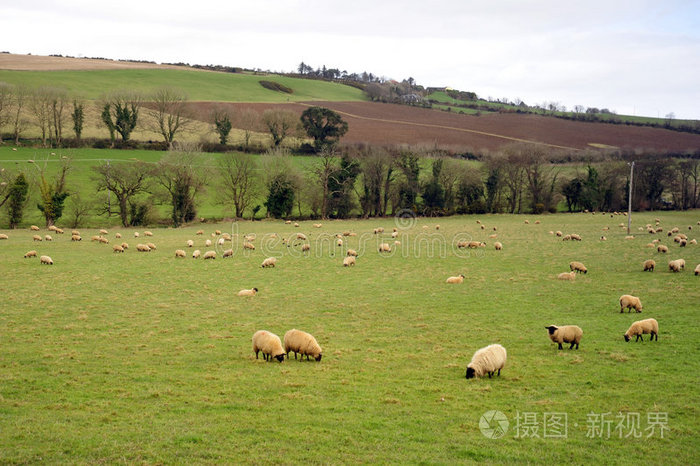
[193, 102, 700, 152]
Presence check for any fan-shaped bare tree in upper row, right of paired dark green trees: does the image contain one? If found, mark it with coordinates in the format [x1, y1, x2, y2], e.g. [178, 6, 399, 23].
[148, 87, 192, 149]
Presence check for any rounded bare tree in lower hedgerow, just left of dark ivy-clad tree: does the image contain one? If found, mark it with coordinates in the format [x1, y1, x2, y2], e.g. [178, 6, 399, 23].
[218, 153, 257, 218]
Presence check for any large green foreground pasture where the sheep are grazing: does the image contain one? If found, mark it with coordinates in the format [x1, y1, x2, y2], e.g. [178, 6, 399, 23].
[0, 211, 700, 464]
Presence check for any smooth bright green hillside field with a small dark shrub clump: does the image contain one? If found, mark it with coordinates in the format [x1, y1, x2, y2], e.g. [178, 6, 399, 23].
[0, 70, 366, 102]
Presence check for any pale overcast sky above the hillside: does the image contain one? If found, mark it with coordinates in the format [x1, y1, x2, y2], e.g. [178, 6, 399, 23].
[5, 0, 700, 119]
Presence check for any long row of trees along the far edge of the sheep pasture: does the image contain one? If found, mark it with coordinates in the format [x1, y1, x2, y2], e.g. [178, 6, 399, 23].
[0, 144, 700, 228]
